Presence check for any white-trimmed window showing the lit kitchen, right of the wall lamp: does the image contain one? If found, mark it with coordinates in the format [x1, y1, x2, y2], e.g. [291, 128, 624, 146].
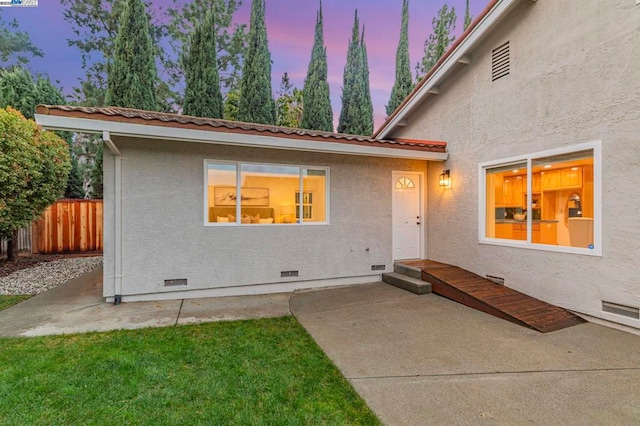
[479, 142, 602, 255]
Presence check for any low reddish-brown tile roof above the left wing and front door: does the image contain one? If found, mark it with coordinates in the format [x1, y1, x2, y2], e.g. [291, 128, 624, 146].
[36, 105, 447, 152]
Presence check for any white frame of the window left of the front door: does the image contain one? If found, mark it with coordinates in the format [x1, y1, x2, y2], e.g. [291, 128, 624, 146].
[203, 158, 331, 228]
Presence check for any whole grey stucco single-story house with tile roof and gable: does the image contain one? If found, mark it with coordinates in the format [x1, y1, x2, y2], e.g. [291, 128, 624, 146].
[36, 0, 640, 328]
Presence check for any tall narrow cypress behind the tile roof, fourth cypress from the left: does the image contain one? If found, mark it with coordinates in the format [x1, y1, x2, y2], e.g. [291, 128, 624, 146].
[300, 2, 333, 132]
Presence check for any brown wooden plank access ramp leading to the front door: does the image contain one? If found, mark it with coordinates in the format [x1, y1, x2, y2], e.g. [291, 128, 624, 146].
[400, 260, 585, 333]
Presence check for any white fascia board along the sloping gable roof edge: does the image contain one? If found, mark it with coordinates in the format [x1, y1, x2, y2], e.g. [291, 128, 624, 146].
[377, 0, 521, 139]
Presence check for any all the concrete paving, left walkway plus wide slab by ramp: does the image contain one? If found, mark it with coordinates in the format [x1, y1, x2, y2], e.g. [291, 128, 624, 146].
[0, 270, 640, 425]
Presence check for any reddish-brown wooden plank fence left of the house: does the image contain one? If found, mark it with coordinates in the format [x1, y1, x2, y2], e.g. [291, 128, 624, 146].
[31, 199, 103, 253]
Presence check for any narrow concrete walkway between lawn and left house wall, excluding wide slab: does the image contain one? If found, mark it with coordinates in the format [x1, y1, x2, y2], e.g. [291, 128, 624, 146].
[0, 268, 291, 337]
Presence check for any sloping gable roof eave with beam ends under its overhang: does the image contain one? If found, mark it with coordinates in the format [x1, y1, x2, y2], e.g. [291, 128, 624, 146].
[373, 0, 522, 139]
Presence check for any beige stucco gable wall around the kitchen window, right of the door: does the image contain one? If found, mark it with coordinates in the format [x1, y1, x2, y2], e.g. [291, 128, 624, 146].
[392, 0, 640, 327]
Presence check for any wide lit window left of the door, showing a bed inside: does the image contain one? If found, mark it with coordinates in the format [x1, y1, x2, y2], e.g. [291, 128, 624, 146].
[205, 160, 329, 226]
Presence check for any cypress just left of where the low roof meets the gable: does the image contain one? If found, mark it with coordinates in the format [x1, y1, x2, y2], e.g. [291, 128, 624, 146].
[338, 10, 373, 135]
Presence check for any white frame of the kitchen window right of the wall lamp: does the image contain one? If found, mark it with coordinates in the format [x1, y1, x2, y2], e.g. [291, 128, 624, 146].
[478, 140, 602, 256]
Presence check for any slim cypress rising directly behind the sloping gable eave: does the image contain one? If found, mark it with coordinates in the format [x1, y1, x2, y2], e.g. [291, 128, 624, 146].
[386, 0, 413, 115]
